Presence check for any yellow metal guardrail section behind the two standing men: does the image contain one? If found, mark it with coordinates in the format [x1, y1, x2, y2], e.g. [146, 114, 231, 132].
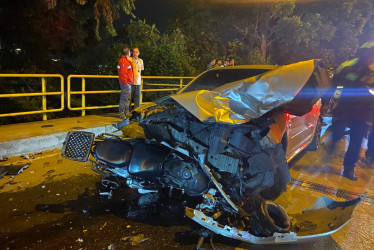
[67, 75, 194, 116]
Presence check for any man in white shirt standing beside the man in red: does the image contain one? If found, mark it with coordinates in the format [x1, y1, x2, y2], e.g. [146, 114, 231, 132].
[131, 48, 144, 109]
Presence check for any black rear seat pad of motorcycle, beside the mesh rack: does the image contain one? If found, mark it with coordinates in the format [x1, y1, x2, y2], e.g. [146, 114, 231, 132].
[93, 140, 132, 167]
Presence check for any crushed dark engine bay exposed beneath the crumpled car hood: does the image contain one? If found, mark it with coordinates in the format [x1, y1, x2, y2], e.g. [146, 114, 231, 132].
[139, 104, 289, 201]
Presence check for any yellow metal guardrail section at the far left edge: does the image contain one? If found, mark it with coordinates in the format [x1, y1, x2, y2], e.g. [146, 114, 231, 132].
[0, 74, 64, 121]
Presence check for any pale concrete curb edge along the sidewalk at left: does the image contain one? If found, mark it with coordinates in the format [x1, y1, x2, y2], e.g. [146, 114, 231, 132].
[0, 125, 122, 157]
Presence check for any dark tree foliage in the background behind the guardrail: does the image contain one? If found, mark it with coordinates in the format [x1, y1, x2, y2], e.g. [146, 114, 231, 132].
[0, 0, 374, 123]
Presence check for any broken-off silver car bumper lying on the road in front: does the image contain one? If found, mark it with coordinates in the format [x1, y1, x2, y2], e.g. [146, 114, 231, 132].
[186, 193, 366, 244]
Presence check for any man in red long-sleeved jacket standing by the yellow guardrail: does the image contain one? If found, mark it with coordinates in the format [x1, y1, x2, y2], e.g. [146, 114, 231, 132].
[117, 47, 134, 119]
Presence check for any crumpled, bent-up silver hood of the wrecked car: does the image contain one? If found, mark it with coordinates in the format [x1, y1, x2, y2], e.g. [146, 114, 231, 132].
[171, 60, 328, 124]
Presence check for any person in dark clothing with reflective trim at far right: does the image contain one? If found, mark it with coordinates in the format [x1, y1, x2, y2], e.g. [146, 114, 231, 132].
[328, 43, 374, 181]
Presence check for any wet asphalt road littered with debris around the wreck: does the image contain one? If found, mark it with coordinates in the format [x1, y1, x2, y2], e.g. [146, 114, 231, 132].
[0, 125, 374, 249]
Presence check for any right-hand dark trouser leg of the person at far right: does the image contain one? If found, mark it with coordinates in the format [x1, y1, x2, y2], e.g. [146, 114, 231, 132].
[343, 120, 368, 173]
